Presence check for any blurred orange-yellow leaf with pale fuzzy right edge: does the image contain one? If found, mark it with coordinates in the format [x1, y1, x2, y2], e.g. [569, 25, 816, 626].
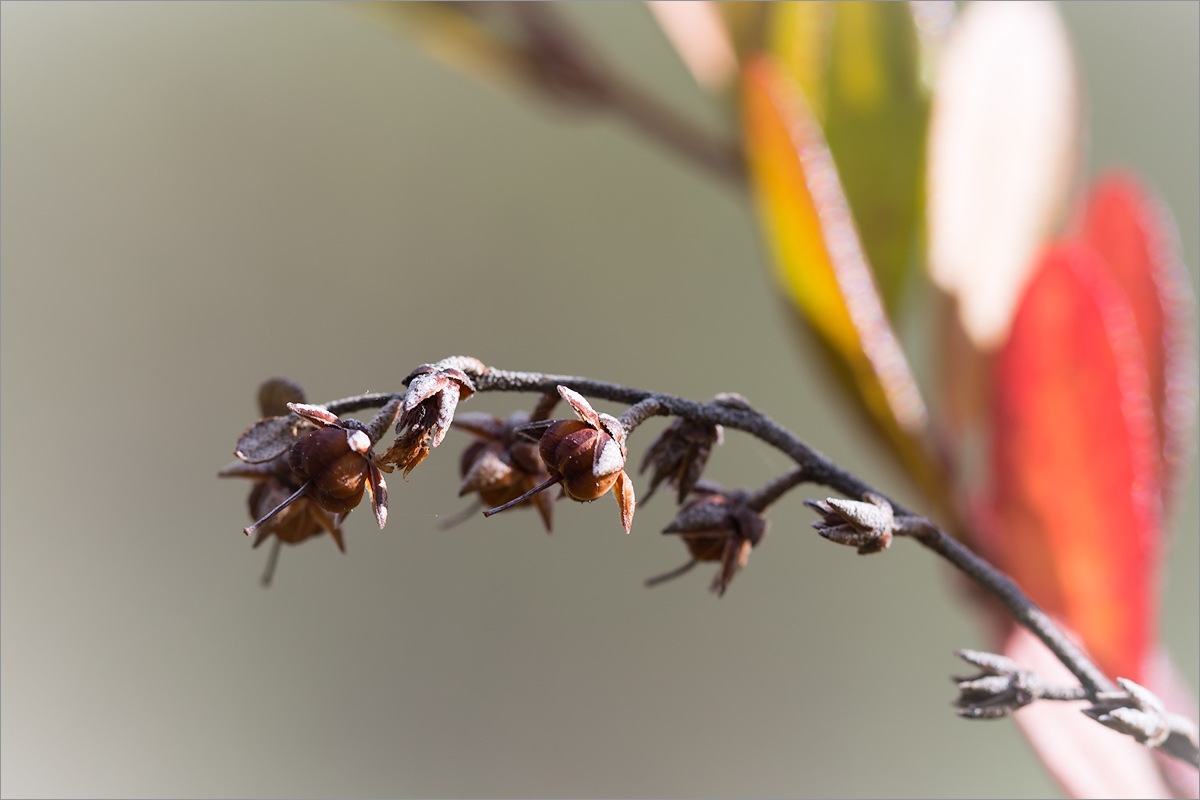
[743, 58, 930, 486]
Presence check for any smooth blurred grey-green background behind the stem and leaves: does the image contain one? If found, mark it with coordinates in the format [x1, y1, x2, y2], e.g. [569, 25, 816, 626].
[0, 2, 1200, 798]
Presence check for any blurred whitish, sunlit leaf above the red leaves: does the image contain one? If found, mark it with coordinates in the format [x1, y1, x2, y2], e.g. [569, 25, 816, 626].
[926, 2, 1082, 350]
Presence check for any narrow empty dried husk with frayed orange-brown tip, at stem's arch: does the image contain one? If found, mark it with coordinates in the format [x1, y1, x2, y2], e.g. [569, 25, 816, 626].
[382, 363, 482, 479]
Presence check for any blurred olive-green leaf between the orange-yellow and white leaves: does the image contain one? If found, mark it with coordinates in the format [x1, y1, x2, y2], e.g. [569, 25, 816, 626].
[824, 2, 929, 311]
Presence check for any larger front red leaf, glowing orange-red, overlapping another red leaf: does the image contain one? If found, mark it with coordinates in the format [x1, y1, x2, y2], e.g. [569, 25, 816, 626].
[985, 242, 1162, 681]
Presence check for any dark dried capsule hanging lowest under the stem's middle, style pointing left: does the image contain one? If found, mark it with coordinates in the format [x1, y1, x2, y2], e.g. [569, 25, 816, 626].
[646, 492, 770, 596]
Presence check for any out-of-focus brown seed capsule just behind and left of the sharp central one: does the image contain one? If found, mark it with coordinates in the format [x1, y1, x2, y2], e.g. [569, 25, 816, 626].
[454, 411, 554, 534]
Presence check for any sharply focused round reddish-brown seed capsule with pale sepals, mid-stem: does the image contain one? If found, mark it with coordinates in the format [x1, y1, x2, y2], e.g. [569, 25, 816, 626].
[485, 386, 636, 534]
